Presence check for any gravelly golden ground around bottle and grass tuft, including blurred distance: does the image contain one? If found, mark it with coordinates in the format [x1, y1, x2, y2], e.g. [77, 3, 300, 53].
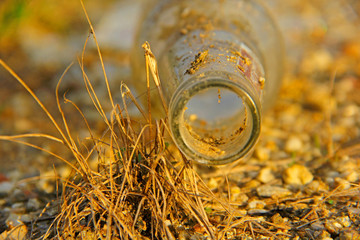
[0, 0, 360, 239]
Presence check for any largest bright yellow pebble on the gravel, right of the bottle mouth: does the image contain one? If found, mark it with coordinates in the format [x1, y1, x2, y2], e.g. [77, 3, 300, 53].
[283, 164, 314, 185]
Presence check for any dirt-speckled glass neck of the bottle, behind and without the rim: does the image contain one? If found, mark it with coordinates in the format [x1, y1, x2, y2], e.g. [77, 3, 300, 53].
[159, 30, 265, 103]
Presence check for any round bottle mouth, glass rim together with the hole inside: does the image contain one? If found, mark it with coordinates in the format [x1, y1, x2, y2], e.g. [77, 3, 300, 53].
[169, 77, 260, 165]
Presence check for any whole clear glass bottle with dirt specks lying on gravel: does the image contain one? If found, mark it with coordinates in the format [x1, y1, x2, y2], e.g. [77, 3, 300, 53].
[132, 0, 283, 165]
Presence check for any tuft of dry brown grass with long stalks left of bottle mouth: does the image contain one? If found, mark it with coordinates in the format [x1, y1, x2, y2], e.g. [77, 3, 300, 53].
[0, 1, 250, 239]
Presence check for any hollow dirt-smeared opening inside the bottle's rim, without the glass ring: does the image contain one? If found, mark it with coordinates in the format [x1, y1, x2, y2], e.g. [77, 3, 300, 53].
[182, 88, 247, 155]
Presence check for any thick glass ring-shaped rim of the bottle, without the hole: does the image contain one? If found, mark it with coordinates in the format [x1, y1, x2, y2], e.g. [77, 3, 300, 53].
[169, 72, 261, 165]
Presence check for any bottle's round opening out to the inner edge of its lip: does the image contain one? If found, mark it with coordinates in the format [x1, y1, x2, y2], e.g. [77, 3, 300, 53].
[179, 84, 254, 164]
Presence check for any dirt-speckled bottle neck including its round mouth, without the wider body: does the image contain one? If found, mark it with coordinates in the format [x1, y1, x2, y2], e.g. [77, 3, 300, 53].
[160, 31, 264, 165]
